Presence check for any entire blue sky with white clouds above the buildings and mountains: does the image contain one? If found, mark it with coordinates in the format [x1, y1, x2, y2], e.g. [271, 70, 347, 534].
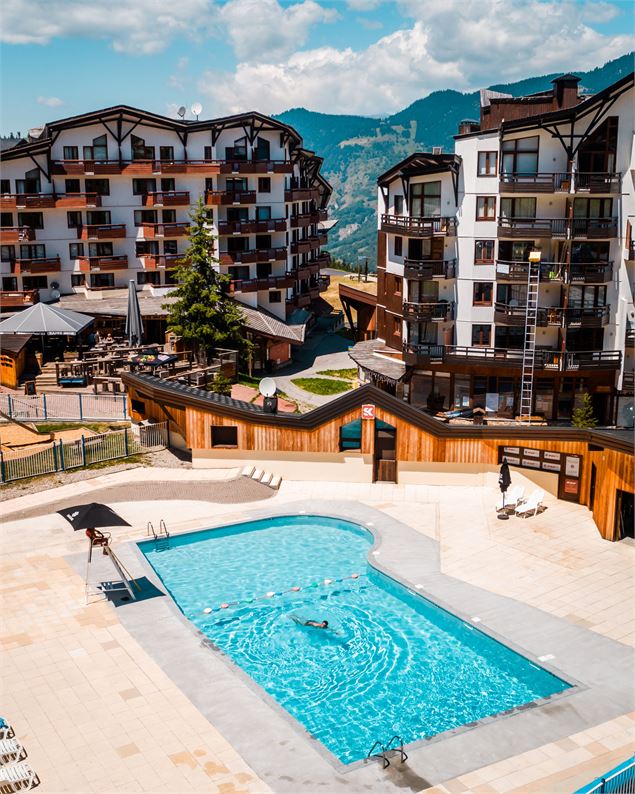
[0, 0, 634, 133]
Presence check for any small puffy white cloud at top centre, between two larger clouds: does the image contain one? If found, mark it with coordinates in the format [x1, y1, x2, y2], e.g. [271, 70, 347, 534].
[219, 0, 338, 62]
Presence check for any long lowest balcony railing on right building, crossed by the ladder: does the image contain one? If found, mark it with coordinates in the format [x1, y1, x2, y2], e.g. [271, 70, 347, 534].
[403, 343, 622, 372]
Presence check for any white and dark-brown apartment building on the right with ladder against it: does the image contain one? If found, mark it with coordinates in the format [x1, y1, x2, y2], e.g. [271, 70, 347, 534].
[351, 74, 635, 424]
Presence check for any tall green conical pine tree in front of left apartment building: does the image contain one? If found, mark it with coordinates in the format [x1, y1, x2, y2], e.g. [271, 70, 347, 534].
[164, 198, 252, 363]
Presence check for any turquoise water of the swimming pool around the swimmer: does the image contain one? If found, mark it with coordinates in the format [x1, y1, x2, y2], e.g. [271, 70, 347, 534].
[139, 516, 569, 763]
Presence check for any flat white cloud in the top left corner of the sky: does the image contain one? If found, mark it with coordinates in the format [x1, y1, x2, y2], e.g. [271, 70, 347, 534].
[0, 0, 217, 55]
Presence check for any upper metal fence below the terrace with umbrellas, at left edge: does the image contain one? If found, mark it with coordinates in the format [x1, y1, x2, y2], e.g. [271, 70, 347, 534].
[0, 392, 128, 421]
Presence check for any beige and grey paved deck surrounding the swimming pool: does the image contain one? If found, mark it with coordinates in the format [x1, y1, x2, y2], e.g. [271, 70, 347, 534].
[0, 470, 635, 794]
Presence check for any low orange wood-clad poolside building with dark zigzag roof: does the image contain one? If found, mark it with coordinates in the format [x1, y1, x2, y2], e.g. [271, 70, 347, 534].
[124, 375, 635, 540]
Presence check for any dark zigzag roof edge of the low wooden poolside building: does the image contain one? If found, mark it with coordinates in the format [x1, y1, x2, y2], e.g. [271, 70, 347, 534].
[122, 373, 633, 455]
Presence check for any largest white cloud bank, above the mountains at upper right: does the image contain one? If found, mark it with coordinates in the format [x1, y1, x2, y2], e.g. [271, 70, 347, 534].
[198, 0, 632, 115]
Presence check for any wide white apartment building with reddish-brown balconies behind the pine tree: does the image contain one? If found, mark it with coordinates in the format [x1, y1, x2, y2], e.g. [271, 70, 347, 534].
[0, 105, 331, 362]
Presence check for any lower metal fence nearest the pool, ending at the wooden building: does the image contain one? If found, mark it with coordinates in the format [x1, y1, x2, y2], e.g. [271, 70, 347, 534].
[0, 422, 168, 483]
